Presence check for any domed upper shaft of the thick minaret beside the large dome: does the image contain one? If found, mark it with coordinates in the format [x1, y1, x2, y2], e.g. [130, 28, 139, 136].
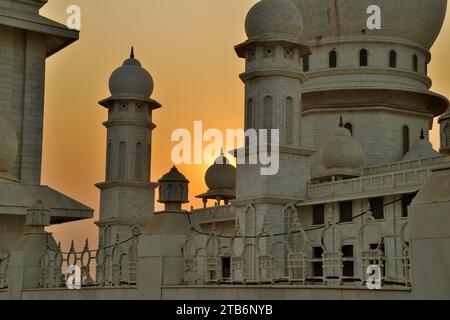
[235, 0, 309, 146]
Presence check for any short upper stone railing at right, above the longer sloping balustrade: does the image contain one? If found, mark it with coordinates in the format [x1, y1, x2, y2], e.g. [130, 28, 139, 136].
[363, 156, 449, 176]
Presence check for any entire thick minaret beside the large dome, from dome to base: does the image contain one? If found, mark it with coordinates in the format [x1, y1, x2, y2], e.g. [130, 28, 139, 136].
[233, 0, 313, 281]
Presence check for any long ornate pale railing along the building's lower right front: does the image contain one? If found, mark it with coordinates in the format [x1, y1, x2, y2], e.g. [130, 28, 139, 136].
[183, 216, 411, 288]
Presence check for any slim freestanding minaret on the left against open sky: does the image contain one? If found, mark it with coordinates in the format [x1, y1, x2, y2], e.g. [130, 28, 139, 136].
[97, 48, 161, 246]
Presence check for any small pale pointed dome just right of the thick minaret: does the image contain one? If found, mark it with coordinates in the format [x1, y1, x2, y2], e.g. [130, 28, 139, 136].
[320, 121, 364, 169]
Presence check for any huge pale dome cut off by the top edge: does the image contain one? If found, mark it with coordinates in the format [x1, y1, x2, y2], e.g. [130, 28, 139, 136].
[291, 0, 447, 49]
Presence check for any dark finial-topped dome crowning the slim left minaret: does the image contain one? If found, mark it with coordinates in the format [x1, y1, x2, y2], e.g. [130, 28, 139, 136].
[109, 49, 154, 99]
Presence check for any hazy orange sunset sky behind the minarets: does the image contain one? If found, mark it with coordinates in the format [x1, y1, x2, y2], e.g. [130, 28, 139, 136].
[41, 0, 450, 249]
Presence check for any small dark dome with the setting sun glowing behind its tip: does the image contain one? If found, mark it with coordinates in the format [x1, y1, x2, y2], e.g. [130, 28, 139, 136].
[205, 152, 236, 190]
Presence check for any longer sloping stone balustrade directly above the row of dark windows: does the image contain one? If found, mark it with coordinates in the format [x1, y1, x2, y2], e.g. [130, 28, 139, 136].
[308, 168, 431, 198]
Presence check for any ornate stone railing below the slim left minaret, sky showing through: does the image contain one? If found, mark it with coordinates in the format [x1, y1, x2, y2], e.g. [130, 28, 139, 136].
[40, 235, 138, 288]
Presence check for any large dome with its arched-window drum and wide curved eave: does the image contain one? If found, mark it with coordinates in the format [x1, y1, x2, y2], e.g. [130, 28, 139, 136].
[290, 0, 449, 169]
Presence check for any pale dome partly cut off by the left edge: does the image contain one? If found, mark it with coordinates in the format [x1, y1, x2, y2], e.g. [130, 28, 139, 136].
[0, 114, 17, 173]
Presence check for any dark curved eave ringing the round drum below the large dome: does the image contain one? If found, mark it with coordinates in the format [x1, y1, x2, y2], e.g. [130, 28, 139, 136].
[302, 87, 449, 117]
